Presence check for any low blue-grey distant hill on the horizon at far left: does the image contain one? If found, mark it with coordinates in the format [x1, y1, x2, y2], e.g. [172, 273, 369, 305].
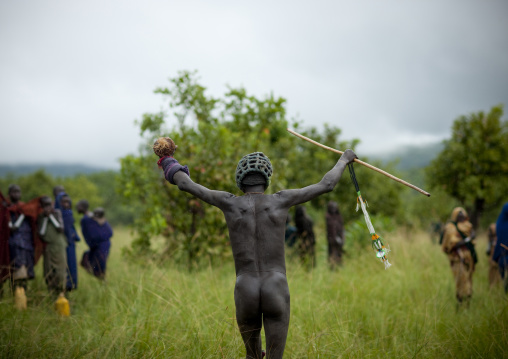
[0, 163, 110, 177]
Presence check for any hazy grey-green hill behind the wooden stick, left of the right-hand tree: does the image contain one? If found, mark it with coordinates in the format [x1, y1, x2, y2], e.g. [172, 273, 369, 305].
[369, 142, 444, 171]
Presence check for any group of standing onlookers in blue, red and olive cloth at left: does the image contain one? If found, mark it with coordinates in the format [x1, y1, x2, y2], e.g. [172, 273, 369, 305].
[0, 184, 113, 308]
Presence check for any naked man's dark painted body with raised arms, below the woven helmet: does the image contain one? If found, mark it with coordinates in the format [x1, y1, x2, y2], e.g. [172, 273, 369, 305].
[169, 150, 357, 359]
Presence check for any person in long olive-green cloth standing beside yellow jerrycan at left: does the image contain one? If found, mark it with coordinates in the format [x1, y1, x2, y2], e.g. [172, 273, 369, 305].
[37, 196, 67, 298]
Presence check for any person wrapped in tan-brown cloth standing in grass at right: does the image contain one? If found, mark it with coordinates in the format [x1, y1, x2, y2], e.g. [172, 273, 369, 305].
[441, 207, 477, 309]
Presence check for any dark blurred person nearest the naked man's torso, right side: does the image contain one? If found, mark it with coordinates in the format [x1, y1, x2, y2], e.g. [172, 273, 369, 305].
[295, 206, 316, 269]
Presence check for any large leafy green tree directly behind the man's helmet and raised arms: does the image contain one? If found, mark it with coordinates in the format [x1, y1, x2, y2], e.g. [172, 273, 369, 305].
[118, 71, 399, 267]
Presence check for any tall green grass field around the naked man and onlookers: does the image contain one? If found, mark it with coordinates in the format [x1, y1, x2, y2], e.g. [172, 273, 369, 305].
[0, 229, 508, 358]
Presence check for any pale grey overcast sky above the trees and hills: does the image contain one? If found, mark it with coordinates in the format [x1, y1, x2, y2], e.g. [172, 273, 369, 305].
[0, 0, 508, 168]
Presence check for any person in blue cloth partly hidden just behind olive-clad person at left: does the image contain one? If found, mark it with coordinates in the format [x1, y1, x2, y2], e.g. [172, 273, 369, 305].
[53, 186, 80, 291]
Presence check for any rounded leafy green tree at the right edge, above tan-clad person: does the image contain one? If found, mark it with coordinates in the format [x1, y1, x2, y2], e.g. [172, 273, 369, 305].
[427, 105, 508, 227]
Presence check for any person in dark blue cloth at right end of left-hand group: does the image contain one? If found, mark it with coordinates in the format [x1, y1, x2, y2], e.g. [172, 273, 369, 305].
[78, 205, 113, 279]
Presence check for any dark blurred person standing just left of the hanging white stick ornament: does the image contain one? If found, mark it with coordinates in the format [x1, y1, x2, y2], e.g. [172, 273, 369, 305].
[326, 201, 344, 269]
